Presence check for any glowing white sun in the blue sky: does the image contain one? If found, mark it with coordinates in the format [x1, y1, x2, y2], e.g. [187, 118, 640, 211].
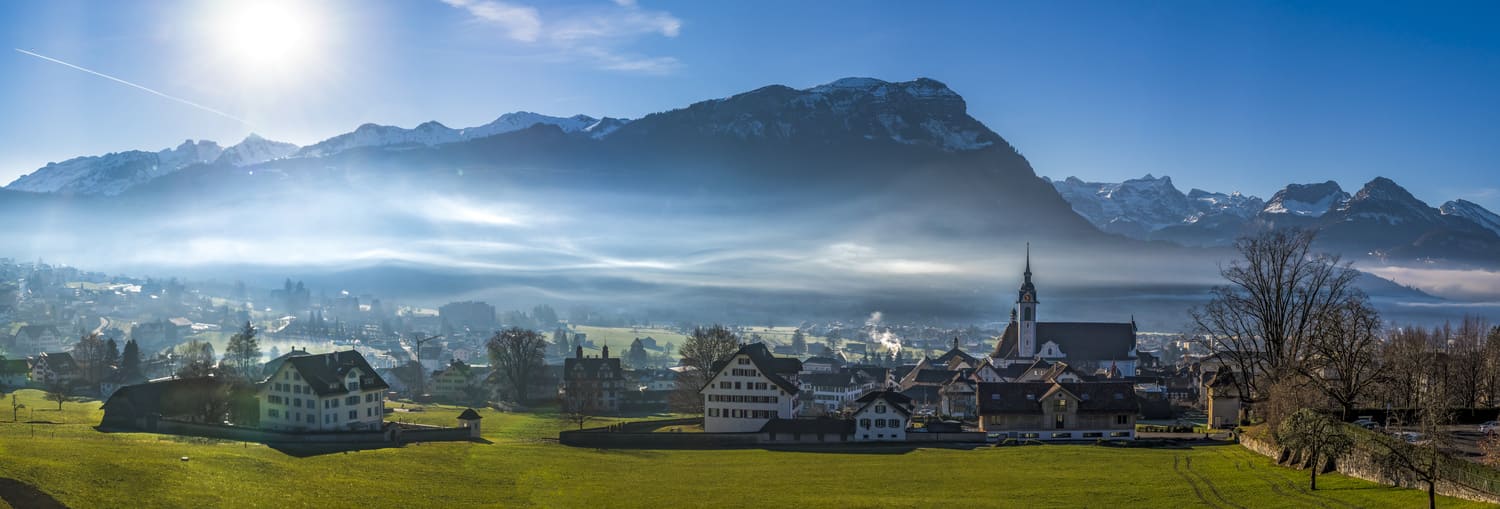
[213, 0, 321, 74]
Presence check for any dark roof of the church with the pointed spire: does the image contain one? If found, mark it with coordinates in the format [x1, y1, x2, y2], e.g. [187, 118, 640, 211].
[990, 321, 1136, 362]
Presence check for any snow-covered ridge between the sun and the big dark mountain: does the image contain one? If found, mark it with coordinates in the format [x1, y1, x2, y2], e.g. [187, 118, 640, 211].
[297, 111, 615, 158]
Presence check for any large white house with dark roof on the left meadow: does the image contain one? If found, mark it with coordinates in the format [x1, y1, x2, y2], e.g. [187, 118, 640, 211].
[255, 350, 390, 431]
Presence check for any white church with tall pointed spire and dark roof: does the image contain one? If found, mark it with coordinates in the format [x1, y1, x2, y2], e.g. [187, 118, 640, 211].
[990, 245, 1136, 378]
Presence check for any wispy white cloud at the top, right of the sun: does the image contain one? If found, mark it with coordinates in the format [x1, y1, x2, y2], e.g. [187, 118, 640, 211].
[443, 0, 683, 74]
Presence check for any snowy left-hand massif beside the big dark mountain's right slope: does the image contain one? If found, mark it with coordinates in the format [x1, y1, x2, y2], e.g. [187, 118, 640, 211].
[1047, 174, 1263, 239]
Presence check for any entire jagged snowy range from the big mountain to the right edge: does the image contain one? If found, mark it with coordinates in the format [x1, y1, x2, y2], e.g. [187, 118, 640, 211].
[1049, 174, 1500, 267]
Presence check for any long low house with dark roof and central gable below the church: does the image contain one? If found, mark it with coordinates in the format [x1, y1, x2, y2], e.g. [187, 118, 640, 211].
[977, 381, 1140, 440]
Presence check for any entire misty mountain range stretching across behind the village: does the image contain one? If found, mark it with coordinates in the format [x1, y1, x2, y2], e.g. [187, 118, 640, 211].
[0, 78, 1482, 320]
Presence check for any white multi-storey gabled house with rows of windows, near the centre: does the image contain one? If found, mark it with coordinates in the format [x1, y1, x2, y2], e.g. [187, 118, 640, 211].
[699, 342, 803, 432]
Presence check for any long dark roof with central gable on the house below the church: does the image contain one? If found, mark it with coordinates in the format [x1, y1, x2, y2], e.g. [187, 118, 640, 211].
[977, 381, 1140, 414]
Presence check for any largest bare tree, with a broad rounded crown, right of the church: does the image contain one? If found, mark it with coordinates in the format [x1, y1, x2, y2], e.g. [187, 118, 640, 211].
[1191, 230, 1359, 420]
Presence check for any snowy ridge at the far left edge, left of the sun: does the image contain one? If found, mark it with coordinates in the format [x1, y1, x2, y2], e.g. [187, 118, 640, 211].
[6, 140, 224, 195]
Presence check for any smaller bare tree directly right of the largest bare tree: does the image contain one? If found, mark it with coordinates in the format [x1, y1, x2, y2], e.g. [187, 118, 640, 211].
[1305, 296, 1385, 420]
